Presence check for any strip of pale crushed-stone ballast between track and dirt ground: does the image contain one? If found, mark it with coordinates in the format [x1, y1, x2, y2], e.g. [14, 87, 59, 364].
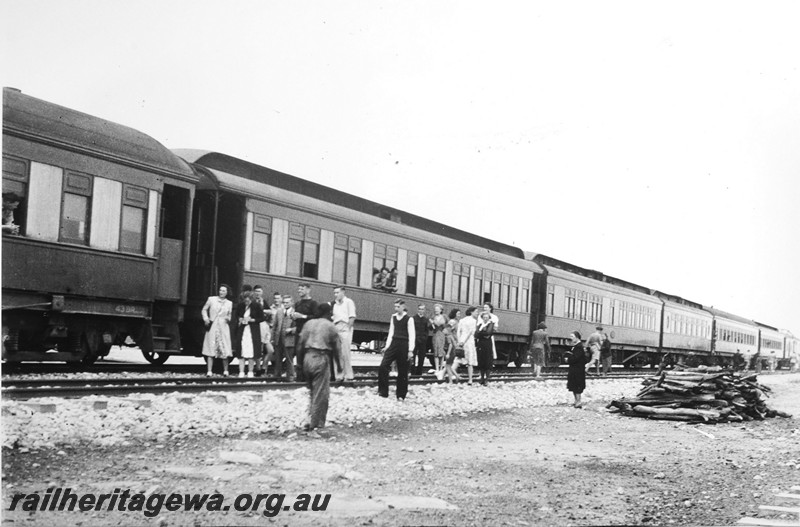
[2, 377, 640, 449]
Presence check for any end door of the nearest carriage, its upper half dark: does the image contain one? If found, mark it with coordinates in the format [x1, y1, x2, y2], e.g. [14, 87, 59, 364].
[156, 185, 190, 300]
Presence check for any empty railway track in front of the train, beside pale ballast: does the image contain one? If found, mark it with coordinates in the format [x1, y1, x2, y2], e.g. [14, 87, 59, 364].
[2, 372, 644, 400]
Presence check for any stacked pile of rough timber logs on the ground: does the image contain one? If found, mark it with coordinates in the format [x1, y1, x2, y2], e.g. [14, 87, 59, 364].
[608, 367, 791, 423]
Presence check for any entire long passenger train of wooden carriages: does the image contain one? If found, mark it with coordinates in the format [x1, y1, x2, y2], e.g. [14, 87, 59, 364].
[2, 88, 800, 372]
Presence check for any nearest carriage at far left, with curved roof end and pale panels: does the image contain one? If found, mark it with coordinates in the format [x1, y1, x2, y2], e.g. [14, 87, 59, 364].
[2, 88, 197, 363]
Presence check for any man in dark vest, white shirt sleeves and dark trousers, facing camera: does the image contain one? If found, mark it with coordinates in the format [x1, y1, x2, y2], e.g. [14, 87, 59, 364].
[378, 299, 415, 401]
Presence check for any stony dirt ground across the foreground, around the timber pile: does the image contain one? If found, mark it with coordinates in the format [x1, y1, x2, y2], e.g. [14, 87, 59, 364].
[3, 375, 800, 527]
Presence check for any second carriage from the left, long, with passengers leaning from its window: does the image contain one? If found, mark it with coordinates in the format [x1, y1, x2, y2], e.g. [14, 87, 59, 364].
[175, 150, 541, 365]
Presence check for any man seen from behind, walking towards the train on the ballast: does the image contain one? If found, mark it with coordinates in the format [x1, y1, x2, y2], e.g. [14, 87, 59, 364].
[297, 303, 341, 432]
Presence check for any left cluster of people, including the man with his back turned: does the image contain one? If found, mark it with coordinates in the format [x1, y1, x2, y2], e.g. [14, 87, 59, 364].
[201, 283, 356, 431]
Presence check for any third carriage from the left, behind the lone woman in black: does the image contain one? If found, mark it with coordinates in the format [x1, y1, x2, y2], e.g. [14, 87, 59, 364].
[528, 253, 662, 366]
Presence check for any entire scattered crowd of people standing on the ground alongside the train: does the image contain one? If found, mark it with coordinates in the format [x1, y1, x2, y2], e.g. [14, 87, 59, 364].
[201, 280, 611, 431]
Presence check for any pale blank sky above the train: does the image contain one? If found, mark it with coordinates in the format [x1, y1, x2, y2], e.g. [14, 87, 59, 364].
[0, 0, 800, 334]
